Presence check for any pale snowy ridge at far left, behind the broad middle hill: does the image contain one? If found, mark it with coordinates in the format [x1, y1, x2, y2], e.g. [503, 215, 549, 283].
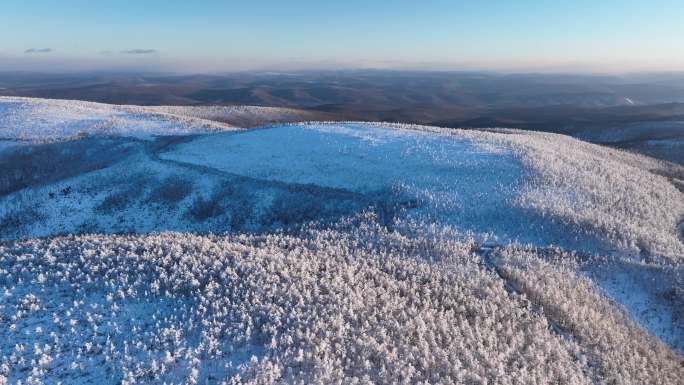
[0, 96, 312, 141]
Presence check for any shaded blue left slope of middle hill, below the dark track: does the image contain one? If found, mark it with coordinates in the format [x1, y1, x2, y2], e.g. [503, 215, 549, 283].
[0, 140, 371, 240]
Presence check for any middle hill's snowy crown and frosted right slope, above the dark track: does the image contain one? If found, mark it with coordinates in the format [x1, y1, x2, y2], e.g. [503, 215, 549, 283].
[162, 123, 684, 259]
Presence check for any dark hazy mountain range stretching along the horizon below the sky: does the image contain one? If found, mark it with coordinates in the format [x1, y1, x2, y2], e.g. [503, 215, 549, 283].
[0, 70, 684, 163]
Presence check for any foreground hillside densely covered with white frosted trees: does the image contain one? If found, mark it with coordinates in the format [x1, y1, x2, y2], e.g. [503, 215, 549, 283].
[0, 217, 684, 385]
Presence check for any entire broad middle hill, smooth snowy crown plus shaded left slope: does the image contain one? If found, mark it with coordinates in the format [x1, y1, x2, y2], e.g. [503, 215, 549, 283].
[0, 123, 684, 260]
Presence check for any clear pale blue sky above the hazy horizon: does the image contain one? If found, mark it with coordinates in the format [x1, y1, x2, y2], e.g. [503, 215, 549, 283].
[0, 0, 684, 73]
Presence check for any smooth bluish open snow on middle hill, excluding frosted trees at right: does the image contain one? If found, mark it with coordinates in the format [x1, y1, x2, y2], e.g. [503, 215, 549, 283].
[162, 123, 598, 250]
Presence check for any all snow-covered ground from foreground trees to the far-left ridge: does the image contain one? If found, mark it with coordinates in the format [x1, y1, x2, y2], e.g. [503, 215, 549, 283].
[0, 98, 684, 384]
